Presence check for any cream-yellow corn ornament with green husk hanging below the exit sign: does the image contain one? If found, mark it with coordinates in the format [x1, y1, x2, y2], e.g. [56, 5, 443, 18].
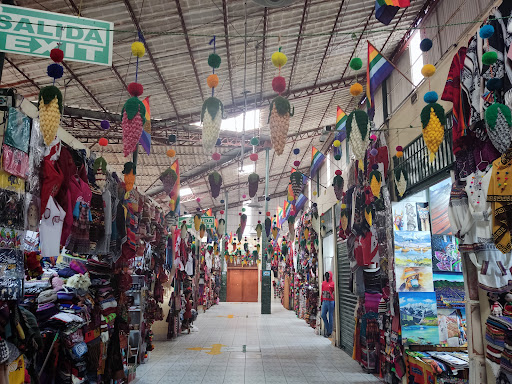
[39, 85, 62, 146]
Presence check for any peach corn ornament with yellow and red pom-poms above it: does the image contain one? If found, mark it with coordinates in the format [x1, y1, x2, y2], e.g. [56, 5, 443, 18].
[268, 47, 293, 156]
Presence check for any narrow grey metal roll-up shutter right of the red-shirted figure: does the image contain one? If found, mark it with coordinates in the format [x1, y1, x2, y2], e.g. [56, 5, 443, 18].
[336, 239, 357, 355]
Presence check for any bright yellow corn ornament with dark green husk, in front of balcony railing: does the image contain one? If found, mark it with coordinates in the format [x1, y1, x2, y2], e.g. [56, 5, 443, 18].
[420, 103, 446, 162]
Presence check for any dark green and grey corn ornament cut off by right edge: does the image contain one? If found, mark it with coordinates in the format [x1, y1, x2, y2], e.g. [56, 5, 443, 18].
[485, 103, 512, 153]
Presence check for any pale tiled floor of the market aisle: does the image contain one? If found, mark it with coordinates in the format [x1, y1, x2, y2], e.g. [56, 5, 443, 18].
[135, 302, 378, 384]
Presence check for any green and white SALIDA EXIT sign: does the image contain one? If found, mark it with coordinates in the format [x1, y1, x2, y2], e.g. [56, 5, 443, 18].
[0, 4, 114, 66]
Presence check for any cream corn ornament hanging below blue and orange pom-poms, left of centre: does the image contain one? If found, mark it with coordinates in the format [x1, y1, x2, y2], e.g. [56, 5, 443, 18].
[201, 36, 224, 154]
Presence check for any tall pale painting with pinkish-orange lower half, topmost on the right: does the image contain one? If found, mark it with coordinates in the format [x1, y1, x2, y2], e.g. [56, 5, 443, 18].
[429, 179, 452, 235]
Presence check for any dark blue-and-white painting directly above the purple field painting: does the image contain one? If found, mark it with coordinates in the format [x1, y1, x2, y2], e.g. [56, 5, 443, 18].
[432, 235, 462, 273]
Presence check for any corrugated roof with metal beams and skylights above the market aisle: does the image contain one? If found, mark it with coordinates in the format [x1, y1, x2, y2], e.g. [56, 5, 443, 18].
[2, 0, 424, 214]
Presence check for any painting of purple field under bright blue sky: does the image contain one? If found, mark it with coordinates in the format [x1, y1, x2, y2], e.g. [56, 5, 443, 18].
[434, 272, 465, 308]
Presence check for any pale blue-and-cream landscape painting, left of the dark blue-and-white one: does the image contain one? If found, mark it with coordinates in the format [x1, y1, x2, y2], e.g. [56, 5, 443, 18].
[395, 231, 432, 267]
